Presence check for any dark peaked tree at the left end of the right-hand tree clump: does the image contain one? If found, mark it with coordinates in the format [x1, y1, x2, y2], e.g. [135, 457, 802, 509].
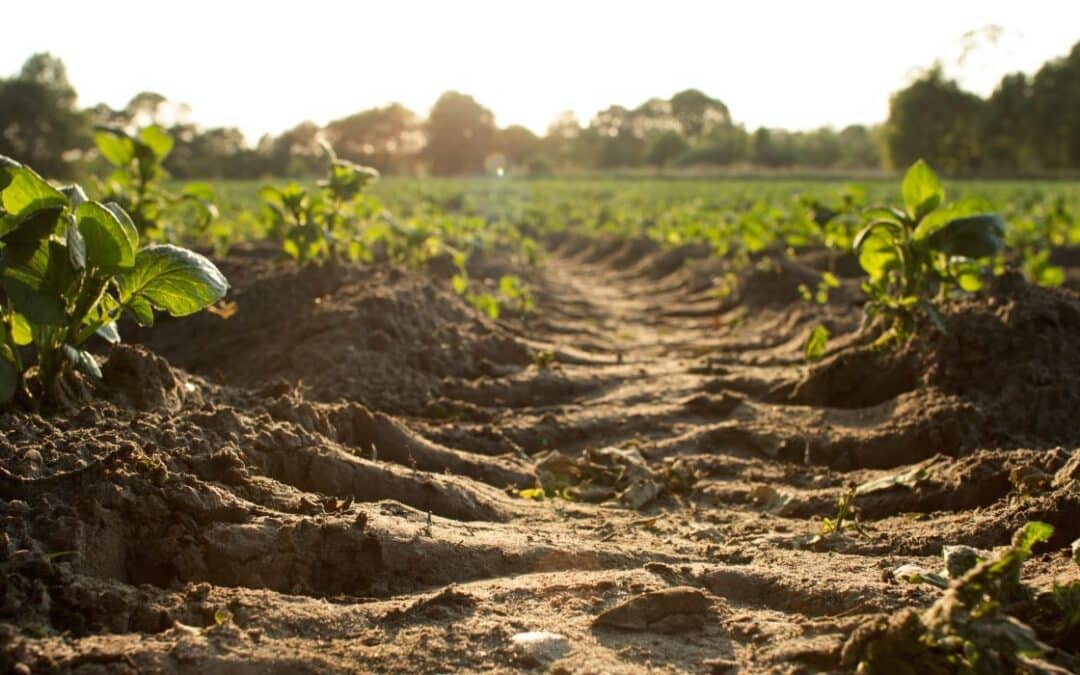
[885, 64, 984, 173]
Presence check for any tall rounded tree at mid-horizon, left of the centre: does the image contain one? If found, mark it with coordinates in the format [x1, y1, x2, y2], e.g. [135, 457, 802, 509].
[423, 92, 495, 175]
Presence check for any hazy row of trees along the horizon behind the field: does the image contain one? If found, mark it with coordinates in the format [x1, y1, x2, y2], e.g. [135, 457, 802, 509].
[0, 43, 1080, 178]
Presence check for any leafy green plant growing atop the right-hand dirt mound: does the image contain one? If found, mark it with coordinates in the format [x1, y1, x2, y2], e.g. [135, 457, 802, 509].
[852, 160, 1005, 338]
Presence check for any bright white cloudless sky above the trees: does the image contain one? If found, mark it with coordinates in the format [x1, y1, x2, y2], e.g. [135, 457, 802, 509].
[0, 0, 1080, 141]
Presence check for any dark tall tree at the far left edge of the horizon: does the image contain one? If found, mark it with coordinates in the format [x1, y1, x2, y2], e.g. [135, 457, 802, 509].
[0, 54, 89, 178]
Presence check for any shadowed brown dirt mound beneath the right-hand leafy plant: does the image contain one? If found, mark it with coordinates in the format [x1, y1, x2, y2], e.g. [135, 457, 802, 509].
[781, 273, 1080, 461]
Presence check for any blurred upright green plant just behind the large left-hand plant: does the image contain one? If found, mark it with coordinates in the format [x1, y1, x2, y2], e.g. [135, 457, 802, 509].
[94, 125, 217, 239]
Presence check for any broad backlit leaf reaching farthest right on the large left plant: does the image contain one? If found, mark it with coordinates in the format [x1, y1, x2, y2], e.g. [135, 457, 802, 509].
[119, 244, 229, 323]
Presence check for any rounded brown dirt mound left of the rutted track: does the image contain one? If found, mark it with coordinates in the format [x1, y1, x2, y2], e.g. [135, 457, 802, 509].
[129, 241, 529, 414]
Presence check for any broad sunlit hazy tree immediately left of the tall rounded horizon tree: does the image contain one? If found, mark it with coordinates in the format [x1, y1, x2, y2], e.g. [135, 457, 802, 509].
[326, 103, 423, 173]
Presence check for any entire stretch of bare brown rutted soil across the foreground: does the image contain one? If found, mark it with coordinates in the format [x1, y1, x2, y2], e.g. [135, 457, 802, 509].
[0, 237, 1080, 673]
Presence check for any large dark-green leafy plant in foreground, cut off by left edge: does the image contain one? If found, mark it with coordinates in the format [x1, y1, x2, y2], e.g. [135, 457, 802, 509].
[0, 156, 229, 405]
